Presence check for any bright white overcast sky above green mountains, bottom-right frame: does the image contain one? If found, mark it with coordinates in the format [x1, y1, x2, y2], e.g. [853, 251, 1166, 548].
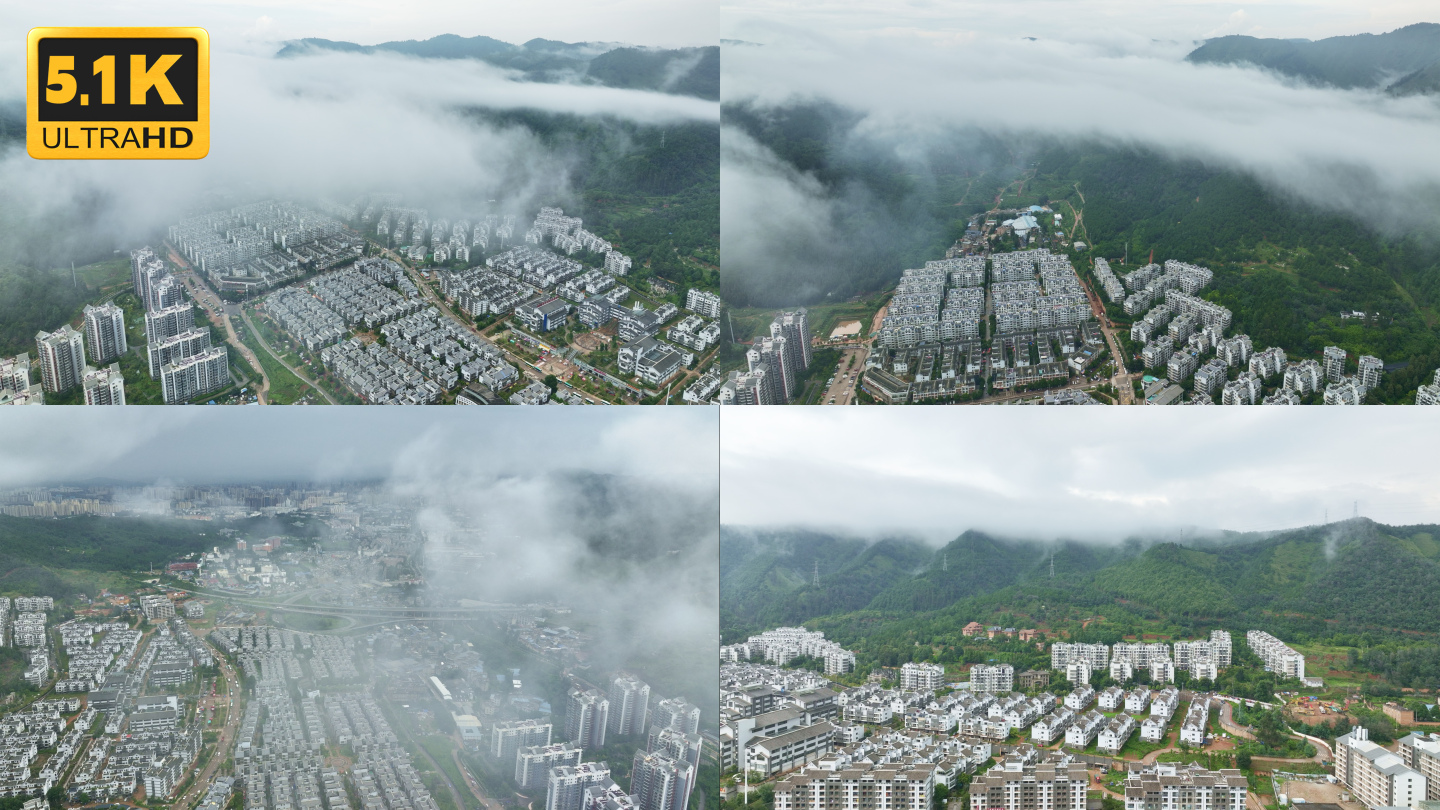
[720, 406, 1440, 542]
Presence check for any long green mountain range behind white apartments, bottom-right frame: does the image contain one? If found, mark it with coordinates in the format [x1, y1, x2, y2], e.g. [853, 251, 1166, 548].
[720, 519, 1440, 640]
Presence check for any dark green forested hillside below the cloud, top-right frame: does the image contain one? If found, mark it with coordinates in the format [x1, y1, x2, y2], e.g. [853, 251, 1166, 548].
[721, 104, 1440, 404]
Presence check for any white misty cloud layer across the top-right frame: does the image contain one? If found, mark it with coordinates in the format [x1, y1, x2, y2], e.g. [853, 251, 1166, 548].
[721, 22, 1440, 305]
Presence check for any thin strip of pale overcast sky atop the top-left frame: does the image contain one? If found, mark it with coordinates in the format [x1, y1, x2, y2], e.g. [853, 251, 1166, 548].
[0, 0, 717, 50]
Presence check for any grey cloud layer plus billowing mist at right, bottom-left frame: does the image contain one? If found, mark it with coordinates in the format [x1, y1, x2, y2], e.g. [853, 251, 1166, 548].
[0, 408, 719, 706]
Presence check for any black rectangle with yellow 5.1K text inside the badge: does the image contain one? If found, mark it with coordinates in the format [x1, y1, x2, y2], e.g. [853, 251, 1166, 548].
[35, 37, 200, 121]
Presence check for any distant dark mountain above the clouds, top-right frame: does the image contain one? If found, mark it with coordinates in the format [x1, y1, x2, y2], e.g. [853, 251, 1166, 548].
[1185, 23, 1440, 92]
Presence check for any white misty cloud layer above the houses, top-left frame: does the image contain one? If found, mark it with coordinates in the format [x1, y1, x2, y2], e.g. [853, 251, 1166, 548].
[0, 50, 719, 262]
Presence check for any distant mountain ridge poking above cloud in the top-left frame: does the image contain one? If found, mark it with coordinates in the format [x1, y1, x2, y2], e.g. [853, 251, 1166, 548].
[275, 33, 720, 101]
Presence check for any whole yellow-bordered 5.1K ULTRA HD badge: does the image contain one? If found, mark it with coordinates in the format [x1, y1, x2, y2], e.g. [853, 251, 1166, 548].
[26, 27, 210, 160]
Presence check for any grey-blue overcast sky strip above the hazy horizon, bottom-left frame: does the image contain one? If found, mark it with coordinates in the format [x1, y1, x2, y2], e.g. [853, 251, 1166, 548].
[0, 406, 719, 491]
